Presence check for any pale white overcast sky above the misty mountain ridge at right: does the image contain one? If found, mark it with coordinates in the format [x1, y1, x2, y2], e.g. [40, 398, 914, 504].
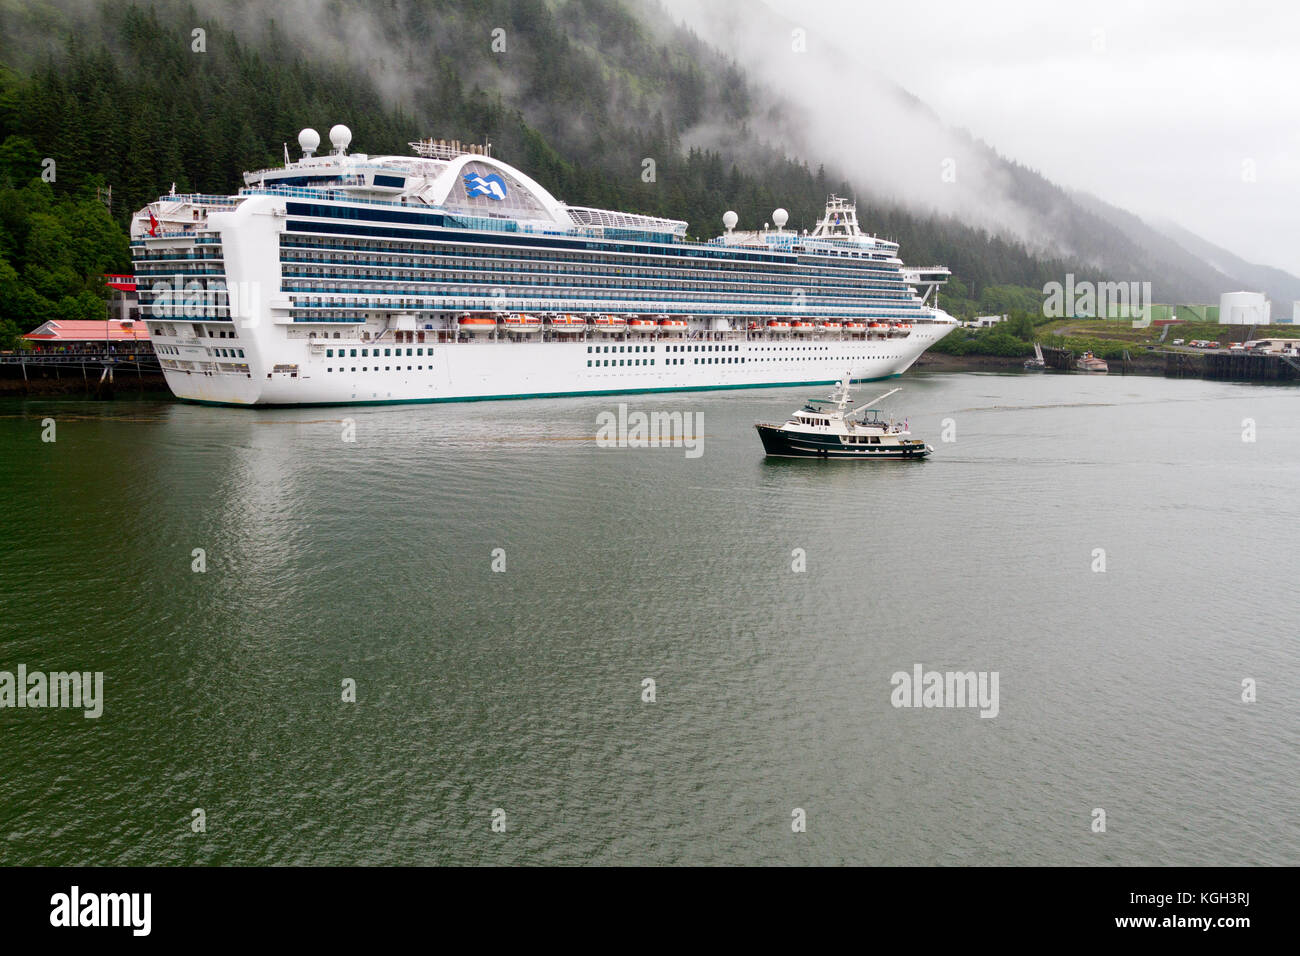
[667, 0, 1300, 273]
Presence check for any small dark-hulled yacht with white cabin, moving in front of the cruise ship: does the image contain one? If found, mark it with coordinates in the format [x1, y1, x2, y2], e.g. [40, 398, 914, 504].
[754, 376, 935, 460]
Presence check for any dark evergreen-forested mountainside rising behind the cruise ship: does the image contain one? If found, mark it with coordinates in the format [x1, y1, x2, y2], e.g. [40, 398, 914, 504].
[0, 0, 1284, 348]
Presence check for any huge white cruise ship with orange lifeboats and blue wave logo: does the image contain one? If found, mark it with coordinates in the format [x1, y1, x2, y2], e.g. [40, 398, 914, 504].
[131, 126, 957, 406]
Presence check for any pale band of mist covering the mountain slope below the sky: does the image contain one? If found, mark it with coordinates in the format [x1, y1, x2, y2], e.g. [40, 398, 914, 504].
[660, 0, 1300, 302]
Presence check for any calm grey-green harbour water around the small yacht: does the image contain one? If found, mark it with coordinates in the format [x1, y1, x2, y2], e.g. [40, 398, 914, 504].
[0, 373, 1300, 865]
